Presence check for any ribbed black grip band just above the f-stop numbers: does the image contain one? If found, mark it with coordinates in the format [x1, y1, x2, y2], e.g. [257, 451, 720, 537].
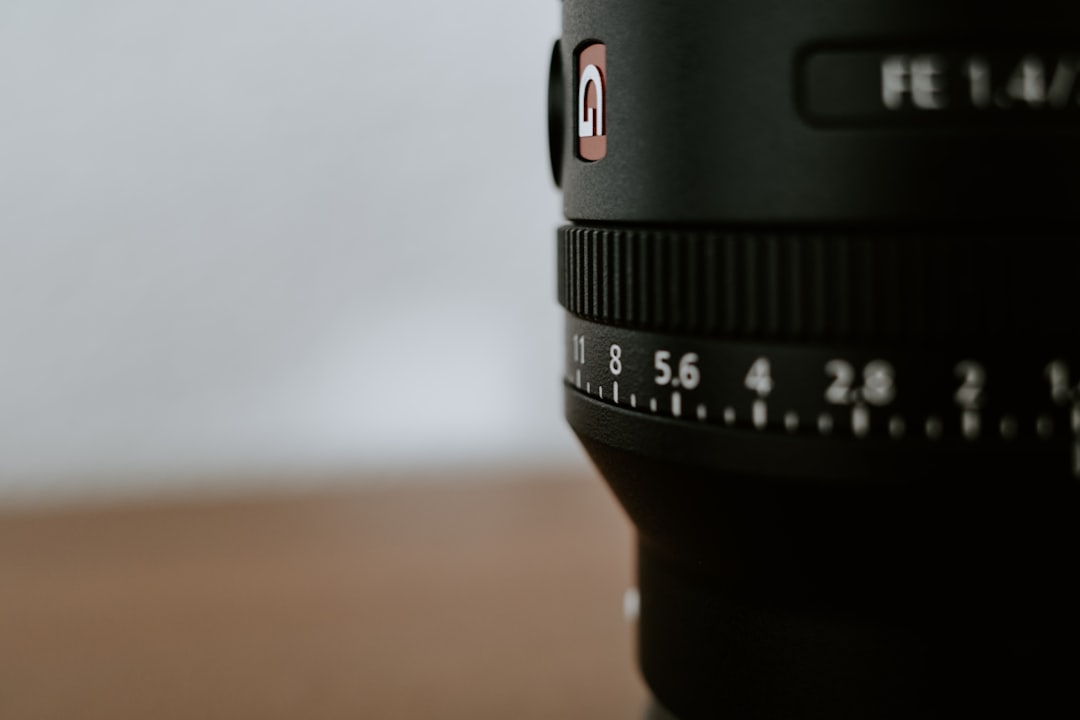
[558, 225, 1080, 341]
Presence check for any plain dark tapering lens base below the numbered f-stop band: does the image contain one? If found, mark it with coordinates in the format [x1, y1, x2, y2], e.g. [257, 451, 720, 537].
[584, 438, 1080, 720]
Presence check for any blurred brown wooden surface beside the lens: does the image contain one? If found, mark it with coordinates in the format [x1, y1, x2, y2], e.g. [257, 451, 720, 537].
[0, 471, 644, 720]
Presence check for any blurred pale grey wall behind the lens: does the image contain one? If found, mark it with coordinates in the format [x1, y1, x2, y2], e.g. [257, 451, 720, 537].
[0, 0, 580, 501]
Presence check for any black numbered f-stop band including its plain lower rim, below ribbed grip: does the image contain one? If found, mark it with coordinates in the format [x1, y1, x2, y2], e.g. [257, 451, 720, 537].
[564, 315, 1080, 481]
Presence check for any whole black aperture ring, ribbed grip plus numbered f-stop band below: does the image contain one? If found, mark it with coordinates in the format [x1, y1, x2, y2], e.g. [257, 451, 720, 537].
[558, 226, 1080, 478]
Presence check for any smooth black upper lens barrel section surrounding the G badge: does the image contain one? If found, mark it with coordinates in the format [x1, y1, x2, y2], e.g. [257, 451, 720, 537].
[562, 0, 1080, 226]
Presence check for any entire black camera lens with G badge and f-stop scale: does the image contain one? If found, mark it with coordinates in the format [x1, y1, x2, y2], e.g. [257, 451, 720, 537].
[549, 0, 1080, 720]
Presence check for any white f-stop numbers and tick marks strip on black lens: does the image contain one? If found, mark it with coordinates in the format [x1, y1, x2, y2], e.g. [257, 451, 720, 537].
[566, 316, 1080, 477]
